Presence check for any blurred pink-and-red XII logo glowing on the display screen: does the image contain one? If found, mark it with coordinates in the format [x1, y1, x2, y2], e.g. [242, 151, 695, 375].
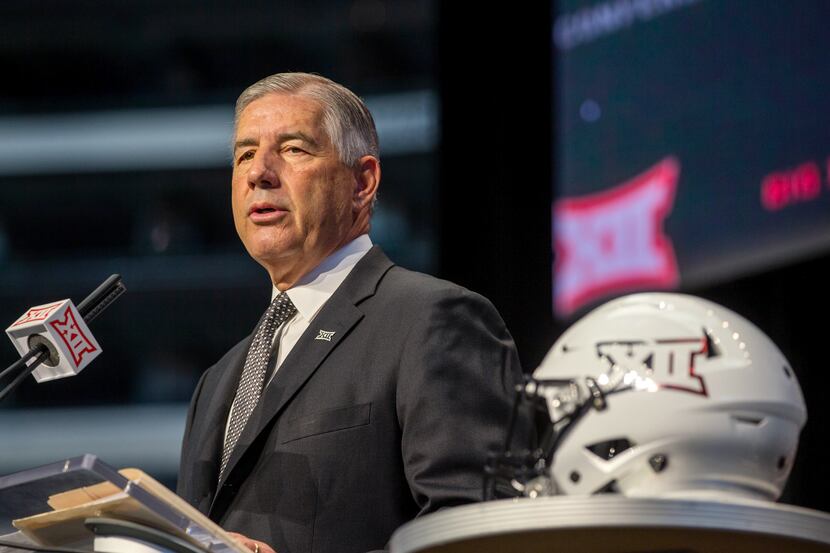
[553, 157, 680, 315]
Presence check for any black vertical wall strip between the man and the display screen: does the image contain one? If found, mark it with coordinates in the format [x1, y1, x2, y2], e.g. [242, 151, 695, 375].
[438, 2, 556, 370]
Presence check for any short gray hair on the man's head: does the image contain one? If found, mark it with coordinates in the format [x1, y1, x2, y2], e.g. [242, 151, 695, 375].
[233, 73, 380, 167]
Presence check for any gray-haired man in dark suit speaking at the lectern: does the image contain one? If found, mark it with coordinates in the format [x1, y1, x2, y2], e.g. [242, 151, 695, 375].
[178, 73, 521, 553]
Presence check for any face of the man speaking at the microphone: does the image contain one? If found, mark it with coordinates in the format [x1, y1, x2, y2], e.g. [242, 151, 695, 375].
[232, 93, 355, 283]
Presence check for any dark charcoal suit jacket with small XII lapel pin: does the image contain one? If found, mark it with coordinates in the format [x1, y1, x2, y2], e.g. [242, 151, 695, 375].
[178, 247, 521, 553]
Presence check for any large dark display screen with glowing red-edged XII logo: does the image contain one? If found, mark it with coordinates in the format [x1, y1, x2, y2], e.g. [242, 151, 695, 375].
[552, 0, 830, 318]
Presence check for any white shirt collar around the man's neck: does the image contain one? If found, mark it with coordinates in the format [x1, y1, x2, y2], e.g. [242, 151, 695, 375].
[271, 234, 372, 321]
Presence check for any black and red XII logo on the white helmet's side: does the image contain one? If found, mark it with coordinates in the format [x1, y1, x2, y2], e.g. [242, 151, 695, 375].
[597, 337, 709, 396]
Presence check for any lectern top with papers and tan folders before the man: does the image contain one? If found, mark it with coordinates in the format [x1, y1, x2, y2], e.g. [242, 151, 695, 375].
[0, 455, 250, 553]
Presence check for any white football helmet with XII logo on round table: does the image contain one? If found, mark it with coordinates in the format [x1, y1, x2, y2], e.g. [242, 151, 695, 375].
[533, 293, 807, 501]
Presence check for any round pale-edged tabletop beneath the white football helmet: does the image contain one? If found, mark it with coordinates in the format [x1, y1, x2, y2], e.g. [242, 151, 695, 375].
[390, 495, 830, 553]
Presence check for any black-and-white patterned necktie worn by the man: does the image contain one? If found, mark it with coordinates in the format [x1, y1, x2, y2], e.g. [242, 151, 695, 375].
[219, 293, 297, 480]
